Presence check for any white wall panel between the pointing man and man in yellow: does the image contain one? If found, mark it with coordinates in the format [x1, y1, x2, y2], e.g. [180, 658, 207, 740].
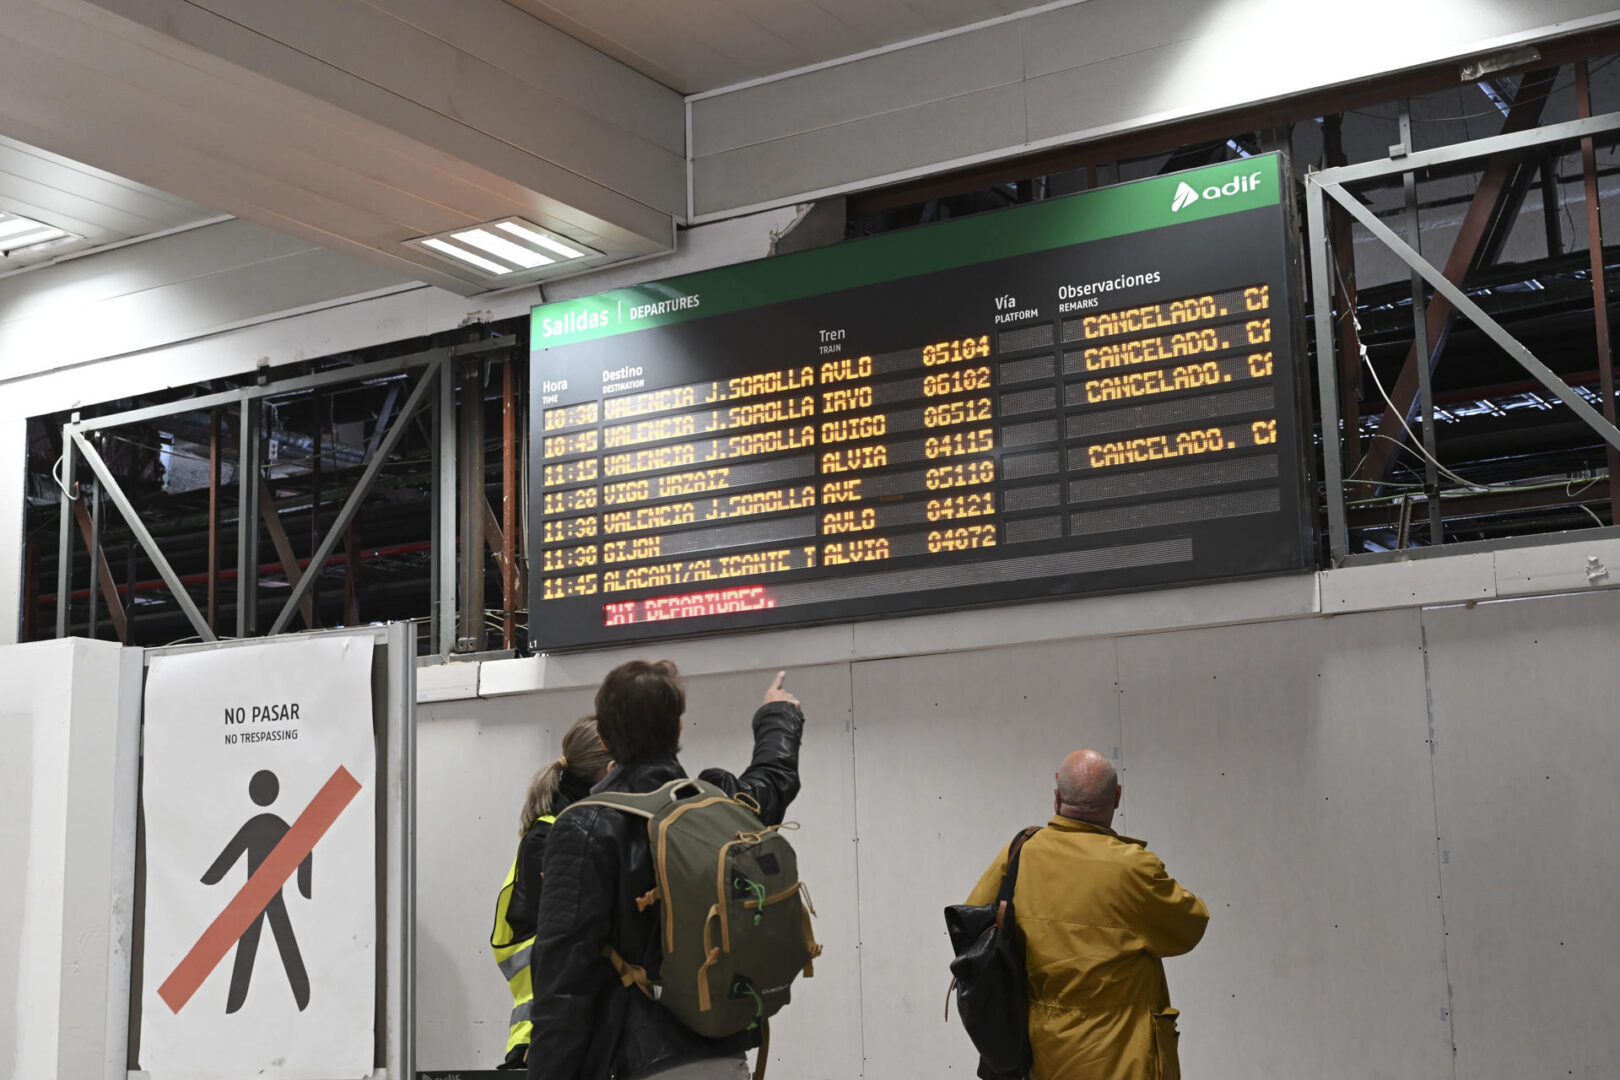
[852, 641, 1119, 1077]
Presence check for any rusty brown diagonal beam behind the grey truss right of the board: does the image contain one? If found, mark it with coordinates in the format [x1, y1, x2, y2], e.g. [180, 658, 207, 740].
[1347, 68, 1557, 486]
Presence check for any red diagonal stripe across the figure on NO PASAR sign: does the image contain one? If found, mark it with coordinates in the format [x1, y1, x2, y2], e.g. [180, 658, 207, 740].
[157, 766, 360, 1012]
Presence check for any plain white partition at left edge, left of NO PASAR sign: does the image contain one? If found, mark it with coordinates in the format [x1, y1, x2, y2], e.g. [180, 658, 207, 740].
[0, 640, 139, 1080]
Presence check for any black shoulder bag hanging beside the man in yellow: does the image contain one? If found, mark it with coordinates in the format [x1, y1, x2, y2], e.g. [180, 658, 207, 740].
[944, 826, 1040, 1080]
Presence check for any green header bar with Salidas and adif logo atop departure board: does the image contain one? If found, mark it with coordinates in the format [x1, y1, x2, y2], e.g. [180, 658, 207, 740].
[530, 154, 1281, 344]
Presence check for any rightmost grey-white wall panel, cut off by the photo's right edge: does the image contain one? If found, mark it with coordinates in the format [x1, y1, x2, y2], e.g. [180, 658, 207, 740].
[1424, 593, 1620, 1080]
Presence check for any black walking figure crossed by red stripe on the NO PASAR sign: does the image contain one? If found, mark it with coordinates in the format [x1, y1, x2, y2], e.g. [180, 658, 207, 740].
[157, 766, 360, 1014]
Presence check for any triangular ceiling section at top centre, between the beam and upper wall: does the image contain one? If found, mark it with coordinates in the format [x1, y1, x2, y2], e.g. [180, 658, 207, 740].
[507, 0, 1050, 94]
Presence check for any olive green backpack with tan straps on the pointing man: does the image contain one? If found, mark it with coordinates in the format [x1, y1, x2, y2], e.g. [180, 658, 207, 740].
[569, 779, 821, 1038]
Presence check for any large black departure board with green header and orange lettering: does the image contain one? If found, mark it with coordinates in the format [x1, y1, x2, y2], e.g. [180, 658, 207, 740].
[528, 155, 1312, 651]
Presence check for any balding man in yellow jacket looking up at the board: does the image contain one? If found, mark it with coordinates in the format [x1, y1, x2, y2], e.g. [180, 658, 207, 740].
[967, 750, 1210, 1080]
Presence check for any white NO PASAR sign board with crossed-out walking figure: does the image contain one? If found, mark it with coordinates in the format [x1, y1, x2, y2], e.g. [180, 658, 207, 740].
[139, 636, 377, 1080]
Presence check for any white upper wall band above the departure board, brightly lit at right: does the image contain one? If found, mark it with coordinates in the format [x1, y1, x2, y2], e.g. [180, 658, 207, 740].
[692, 0, 1620, 219]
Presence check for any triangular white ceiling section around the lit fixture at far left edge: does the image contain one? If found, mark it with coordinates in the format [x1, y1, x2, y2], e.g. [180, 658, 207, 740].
[0, 136, 217, 274]
